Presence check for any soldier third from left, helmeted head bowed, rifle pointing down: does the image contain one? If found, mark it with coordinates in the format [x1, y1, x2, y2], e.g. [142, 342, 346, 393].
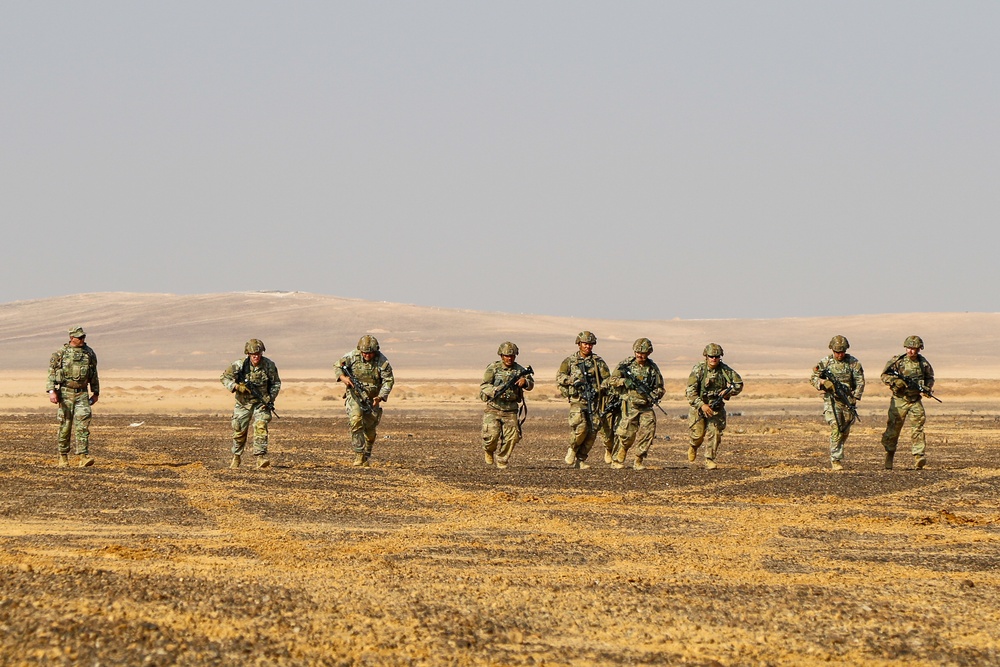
[335, 335, 396, 468]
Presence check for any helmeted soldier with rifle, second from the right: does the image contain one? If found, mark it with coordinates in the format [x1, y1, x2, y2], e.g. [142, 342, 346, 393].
[809, 336, 865, 470]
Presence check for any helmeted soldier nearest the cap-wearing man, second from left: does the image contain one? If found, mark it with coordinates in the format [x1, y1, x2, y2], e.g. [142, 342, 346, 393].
[219, 338, 281, 469]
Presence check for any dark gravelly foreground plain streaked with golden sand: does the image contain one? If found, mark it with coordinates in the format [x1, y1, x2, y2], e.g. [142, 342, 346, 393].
[0, 410, 1000, 665]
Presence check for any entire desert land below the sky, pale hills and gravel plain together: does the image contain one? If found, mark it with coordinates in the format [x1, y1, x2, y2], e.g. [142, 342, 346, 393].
[0, 292, 1000, 666]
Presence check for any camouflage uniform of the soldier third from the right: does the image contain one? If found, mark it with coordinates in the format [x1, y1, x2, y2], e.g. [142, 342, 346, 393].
[684, 350, 743, 469]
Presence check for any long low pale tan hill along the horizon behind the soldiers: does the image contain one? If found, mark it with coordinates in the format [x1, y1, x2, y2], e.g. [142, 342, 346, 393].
[0, 292, 1000, 378]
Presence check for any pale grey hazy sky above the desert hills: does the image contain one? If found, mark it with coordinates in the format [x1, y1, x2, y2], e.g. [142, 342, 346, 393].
[0, 0, 1000, 319]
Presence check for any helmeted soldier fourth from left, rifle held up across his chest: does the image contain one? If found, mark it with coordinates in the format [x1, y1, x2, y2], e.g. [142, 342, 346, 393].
[479, 341, 535, 469]
